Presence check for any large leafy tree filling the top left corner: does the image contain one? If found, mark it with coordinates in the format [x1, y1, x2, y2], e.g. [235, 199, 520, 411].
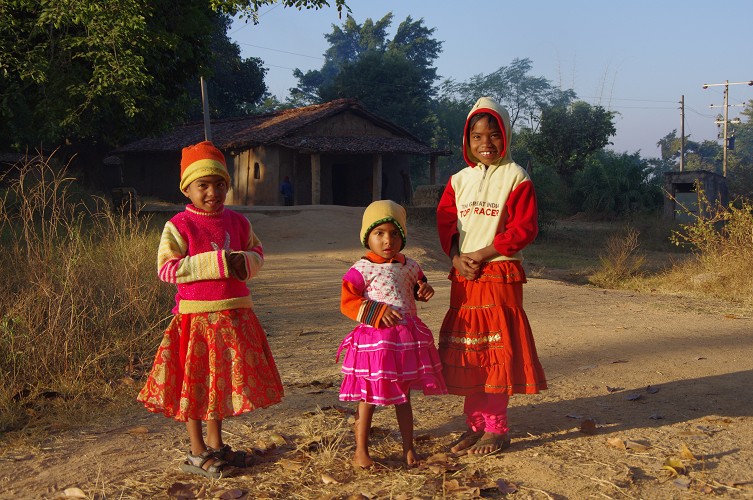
[0, 0, 347, 150]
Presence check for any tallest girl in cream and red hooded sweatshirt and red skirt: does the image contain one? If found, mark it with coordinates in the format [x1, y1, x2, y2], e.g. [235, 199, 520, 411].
[437, 97, 546, 454]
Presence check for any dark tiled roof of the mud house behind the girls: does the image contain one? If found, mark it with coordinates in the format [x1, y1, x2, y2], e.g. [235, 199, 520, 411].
[113, 99, 446, 154]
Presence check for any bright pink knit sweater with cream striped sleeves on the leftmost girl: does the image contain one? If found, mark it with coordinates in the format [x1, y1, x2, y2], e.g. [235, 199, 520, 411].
[157, 205, 264, 313]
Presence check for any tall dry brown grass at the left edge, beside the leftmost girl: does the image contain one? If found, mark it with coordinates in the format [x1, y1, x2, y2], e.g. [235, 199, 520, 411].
[0, 151, 170, 429]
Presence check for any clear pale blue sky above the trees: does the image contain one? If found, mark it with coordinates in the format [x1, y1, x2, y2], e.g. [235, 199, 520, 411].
[229, 0, 753, 158]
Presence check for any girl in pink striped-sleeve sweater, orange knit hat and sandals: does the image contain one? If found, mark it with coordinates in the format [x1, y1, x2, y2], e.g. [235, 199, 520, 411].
[137, 141, 283, 479]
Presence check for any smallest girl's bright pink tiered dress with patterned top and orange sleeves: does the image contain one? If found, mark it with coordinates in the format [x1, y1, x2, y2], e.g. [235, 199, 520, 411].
[337, 253, 447, 406]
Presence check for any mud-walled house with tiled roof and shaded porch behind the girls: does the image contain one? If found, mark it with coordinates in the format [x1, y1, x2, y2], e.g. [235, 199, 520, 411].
[106, 99, 449, 206]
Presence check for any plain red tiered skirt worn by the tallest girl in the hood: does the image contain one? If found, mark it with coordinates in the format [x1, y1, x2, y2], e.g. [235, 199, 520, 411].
[439, 261, 547, 396]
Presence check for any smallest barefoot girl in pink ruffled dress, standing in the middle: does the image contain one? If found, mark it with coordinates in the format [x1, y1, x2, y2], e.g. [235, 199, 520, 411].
[337, 200, 447, 468]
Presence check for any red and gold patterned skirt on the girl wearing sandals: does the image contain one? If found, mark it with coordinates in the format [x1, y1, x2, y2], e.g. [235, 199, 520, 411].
[137, 309, 283, 421]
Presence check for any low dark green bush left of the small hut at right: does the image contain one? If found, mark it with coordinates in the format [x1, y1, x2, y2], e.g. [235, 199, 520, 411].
[572, 151, 663, 217]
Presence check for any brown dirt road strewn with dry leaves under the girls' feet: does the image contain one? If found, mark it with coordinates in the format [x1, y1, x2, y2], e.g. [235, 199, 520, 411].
[0, 207, 753, 499]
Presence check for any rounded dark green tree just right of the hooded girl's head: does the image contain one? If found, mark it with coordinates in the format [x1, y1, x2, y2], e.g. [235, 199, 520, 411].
[528, 101, 616, 181]
